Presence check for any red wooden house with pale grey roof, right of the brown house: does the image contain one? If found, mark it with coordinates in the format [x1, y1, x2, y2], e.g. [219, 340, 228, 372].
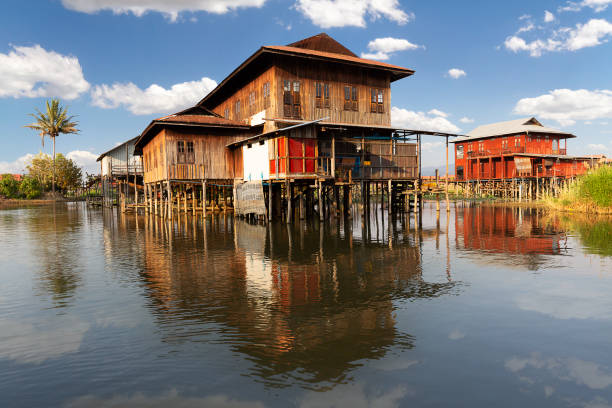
[453, 118, 588, 181]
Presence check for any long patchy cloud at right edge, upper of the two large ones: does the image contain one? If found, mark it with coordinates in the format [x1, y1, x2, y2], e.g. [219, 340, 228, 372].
[504, 19, 612, 57]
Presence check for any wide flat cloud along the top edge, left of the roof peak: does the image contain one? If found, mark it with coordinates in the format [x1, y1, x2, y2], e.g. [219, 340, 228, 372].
[62, 0, 266, 21]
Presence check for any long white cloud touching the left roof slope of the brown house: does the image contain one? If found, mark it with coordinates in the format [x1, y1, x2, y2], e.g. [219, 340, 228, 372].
[91, 78, 217, 115]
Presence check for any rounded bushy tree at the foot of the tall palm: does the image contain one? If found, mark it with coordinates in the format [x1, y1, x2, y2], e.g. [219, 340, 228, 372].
[27, 153, 83, 191]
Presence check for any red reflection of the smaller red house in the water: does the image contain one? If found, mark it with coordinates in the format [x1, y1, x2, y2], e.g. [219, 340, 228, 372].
[455, 205, 567, 269]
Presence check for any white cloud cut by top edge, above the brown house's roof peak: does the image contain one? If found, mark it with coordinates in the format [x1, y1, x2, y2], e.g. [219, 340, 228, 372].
[295, 0, 414, 28]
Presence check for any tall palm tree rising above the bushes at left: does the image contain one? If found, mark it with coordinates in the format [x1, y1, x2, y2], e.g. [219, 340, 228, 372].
[25, 98, 79, 197]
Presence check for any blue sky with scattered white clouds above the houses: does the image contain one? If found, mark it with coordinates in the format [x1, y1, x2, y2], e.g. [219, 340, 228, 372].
[0, 0, 612, 172]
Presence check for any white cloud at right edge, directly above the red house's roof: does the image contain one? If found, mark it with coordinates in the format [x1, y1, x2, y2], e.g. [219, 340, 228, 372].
[514, 89, 612, 126]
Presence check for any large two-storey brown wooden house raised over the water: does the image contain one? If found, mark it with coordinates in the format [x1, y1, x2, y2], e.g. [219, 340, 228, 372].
[136, 34, 454, 220]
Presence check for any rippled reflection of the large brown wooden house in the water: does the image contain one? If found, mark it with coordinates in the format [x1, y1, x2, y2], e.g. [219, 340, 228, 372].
[105, 216, 454, 387]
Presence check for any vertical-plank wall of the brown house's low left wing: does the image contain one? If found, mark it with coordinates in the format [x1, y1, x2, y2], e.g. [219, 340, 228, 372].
[143, 128, 252, 183]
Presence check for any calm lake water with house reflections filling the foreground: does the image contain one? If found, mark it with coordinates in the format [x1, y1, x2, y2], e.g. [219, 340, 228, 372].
[0, 203, 612, 408]
